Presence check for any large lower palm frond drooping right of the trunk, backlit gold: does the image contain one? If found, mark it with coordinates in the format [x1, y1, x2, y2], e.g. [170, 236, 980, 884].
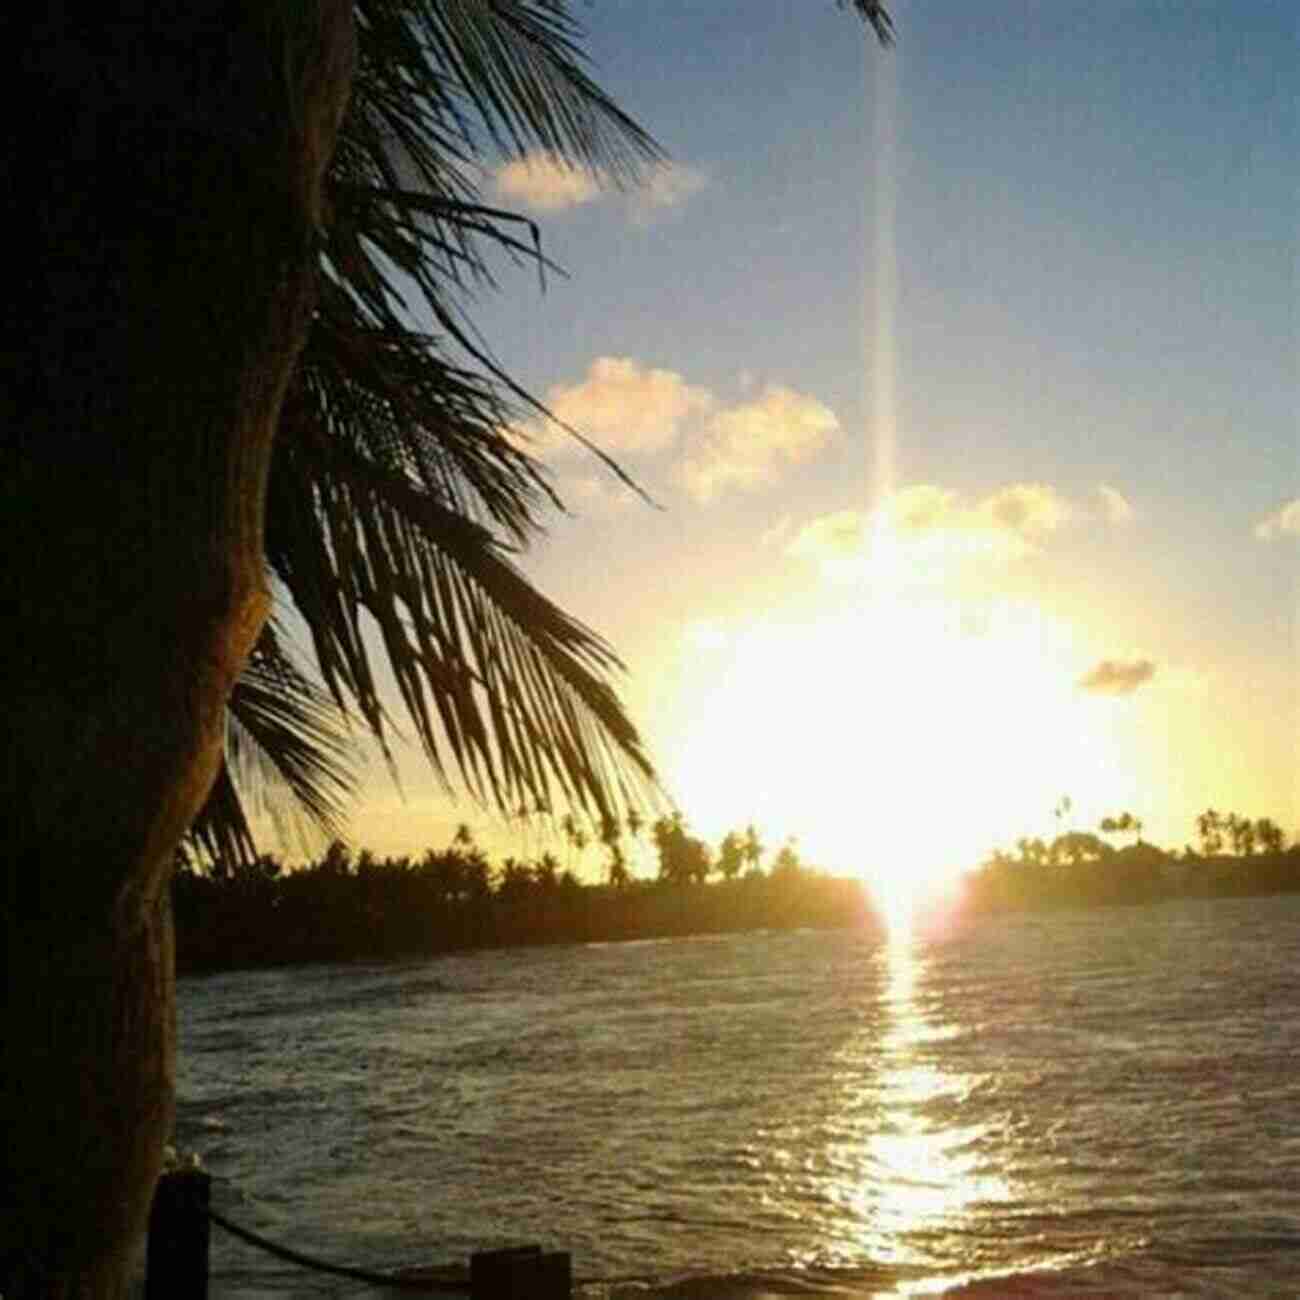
[267, 391, 654, 814]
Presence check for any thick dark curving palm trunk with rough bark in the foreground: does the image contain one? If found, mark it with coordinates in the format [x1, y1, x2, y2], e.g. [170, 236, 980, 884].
[0, 0, 354, 1300]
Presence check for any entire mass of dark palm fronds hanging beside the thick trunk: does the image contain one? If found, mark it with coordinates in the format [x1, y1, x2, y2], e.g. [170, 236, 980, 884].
[213, 0, 892, 857]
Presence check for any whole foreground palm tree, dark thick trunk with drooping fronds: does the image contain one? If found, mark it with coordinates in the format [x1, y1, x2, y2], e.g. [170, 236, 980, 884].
[0, 0, 889, 1300]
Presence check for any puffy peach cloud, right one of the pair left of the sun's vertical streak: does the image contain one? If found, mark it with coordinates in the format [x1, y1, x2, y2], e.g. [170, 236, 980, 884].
[679, 385, 840, 502]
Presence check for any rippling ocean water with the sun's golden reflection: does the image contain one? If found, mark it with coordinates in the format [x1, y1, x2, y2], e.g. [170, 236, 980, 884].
[177, 896, 1300, 1300]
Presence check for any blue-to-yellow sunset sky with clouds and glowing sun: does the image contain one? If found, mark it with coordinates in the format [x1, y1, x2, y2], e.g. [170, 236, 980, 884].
[332, 0, 1300, 894]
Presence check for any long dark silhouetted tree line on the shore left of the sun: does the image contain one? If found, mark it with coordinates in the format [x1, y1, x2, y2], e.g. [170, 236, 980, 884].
[173, 814, 872, 971]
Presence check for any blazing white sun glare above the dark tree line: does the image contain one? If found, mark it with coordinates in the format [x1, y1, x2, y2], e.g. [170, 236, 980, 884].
[668, 522, 1113, 920]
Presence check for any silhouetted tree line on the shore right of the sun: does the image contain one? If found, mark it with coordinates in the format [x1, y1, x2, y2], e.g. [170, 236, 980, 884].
[965, 801, 1300, 911]
